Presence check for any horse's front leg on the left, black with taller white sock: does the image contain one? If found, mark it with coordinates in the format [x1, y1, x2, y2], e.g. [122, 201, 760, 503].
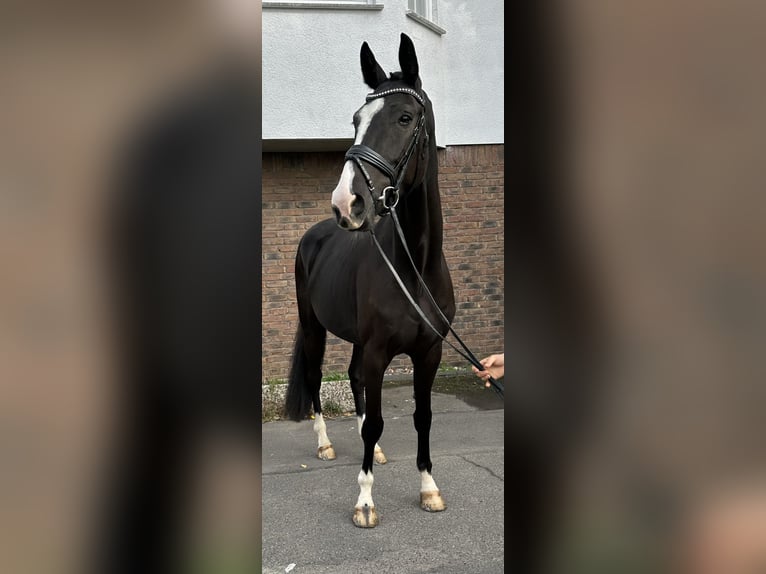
[352, 353, 387, 528]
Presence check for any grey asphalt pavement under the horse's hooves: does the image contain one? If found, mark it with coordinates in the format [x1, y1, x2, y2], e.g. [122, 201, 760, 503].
[262, 384, 505, 574]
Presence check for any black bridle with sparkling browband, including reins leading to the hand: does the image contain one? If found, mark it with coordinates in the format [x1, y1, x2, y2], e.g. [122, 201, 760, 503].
[345, 88, 505, 396]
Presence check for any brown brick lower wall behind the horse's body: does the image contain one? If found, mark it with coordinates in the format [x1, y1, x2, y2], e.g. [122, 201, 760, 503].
[262, 145, 504, 380]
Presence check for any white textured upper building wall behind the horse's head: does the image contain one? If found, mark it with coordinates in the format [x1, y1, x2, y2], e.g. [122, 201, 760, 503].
[262, 0, 503, 146]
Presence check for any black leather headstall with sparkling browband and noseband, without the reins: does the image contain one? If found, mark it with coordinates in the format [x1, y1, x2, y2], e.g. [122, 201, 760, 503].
[345, 88, 428, 216]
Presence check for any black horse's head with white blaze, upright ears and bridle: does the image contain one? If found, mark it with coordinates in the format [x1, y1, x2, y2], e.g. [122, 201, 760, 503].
[332, 34, 433, 231]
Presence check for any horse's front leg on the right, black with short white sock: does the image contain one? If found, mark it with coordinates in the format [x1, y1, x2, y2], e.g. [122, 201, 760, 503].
[412, 345, 447, 512]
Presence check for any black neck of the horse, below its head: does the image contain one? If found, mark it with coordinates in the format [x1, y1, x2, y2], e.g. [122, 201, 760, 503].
[397, 160, 443, 275]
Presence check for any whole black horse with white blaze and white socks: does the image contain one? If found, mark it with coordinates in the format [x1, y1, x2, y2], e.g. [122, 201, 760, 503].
[285, 34, 455, 528]
